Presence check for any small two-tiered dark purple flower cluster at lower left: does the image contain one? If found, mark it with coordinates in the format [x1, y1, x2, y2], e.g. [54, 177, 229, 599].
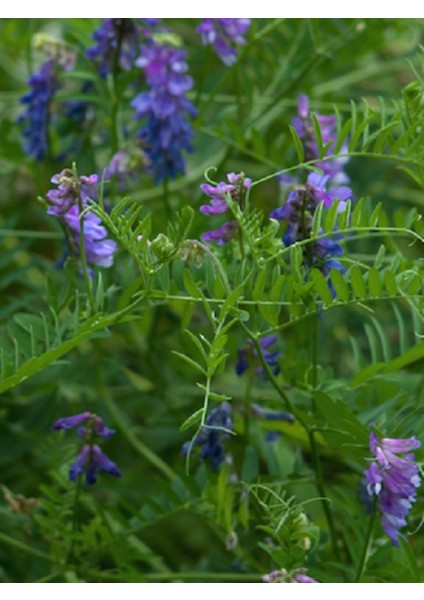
[52, 411, 122, 485]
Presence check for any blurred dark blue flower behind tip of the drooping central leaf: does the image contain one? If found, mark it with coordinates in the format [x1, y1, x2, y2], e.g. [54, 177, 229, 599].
[182, 402, 233, 471]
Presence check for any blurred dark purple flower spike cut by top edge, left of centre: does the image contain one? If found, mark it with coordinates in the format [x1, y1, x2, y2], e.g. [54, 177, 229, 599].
[86, 19, 158, 77]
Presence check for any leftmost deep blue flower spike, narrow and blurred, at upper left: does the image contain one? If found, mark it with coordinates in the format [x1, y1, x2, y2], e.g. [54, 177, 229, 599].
[18, 58, 59, 161]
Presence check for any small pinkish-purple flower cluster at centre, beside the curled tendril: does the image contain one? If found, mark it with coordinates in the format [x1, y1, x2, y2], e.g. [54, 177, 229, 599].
[200, 173, 252, 246]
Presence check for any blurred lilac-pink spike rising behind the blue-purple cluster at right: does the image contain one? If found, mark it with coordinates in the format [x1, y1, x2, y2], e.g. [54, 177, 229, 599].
[292, 95, 349, 184]
